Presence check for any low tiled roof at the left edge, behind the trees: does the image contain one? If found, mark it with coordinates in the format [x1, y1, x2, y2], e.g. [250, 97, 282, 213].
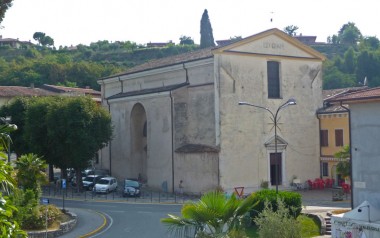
[0, 86, 57, 97]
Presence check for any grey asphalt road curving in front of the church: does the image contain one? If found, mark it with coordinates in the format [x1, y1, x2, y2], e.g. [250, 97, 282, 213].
[50, 199, 182, 238]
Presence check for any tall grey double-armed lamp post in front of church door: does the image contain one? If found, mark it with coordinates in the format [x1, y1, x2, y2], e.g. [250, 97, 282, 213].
[239, 98, 297, 193]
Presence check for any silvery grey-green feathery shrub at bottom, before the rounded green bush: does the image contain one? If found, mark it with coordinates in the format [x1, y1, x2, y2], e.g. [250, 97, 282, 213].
[254, 198, 301, 238]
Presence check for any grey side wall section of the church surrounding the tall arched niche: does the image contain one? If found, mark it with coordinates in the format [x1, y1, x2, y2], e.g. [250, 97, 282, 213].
[110, 95, 172, 188]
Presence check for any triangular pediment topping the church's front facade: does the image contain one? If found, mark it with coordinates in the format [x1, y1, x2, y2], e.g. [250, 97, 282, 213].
[213, 28, 325, 60]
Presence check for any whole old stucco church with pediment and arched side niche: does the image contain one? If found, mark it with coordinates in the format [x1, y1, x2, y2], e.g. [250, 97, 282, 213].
[98, 29, 325, 193]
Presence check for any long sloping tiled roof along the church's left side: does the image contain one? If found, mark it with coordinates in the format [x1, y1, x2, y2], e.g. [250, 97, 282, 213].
[101, 47, 213, 78]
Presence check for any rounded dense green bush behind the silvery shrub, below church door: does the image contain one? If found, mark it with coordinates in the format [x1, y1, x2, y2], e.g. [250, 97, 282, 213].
[251, 189, 302, 218]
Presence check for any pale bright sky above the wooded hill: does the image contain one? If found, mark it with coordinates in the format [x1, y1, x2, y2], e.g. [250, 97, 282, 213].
[0, 0, 380, 47]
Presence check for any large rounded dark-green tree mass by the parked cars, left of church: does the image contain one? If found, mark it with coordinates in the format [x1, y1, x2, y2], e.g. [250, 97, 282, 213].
[25, 96, 112, 186]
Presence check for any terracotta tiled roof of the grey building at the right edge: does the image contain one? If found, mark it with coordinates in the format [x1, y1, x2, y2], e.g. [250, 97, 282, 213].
[329, 87, 380, 102]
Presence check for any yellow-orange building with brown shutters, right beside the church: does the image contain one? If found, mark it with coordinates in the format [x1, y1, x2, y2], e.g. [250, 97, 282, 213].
[317, 87, 367, 186]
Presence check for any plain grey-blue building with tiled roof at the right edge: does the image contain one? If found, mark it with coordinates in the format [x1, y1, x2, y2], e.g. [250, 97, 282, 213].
[331, 87, 380, 209]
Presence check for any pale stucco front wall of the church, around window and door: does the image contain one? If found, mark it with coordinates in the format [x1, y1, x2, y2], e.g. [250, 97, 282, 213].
[216, 38, 322, 193]
